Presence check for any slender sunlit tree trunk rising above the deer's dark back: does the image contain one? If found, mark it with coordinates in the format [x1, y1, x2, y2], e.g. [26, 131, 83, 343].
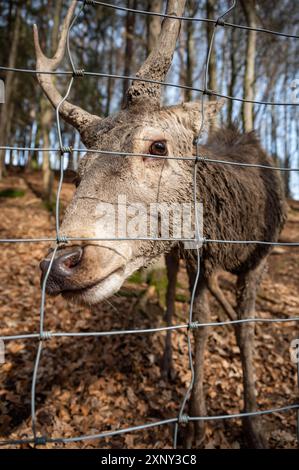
[241, 0, 257, 132]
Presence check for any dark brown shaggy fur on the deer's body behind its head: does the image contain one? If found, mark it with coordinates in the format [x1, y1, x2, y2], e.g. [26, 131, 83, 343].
[185, 127, 286, 277]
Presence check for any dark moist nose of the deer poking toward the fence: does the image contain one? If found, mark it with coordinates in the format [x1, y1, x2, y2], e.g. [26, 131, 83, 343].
[40, 246, 83, 295]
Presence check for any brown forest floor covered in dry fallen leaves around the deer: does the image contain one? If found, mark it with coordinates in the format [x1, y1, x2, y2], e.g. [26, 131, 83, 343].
[0, 174, 299, 449]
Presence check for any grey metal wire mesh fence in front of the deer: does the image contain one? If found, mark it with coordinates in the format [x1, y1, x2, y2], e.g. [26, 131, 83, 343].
[0, 0, 299, 448]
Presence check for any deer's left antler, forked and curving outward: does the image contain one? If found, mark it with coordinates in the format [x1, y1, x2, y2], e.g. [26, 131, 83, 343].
[33, 0, 101, 141]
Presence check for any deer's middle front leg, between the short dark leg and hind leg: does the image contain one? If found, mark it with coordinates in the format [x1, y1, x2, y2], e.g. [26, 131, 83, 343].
[185, 274, 210, 449]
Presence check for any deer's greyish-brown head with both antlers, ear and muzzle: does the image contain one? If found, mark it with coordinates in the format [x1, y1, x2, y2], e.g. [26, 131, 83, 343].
[38, 0, 223, 304]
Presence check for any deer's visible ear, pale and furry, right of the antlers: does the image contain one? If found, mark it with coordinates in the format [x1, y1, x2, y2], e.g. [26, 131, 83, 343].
[181, 99, 224, 136]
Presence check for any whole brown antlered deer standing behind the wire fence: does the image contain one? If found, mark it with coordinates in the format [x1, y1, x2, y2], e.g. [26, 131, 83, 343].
[34, 0, 286, 448]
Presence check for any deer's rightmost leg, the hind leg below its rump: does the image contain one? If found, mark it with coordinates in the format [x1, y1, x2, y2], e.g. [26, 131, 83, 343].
[236, 261, 267, 448]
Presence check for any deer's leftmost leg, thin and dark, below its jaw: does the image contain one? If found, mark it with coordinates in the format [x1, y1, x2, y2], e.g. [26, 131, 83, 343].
[161, 250, 180, 379]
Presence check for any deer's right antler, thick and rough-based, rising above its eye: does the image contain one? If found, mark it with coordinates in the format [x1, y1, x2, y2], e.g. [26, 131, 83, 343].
[127, 0, 186, 107]
